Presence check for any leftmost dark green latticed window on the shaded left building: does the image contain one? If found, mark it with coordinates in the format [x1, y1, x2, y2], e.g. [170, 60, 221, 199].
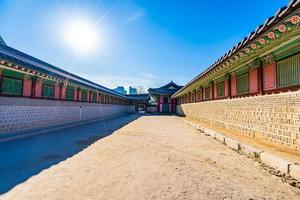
[2, 77, 23, 96]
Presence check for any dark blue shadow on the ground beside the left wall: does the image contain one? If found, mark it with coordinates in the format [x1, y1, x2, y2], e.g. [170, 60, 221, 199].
[0, 115, 140, 194]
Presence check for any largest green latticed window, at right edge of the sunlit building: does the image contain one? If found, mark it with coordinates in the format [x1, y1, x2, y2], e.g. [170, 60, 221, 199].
[277, 54, 300, 87]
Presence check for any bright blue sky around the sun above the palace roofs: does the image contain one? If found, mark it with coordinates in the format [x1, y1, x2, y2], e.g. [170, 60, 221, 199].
[0, 0, 288, 88]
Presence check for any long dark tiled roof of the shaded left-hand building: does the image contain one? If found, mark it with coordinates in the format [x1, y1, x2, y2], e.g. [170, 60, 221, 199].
[0, 44, 127, 98]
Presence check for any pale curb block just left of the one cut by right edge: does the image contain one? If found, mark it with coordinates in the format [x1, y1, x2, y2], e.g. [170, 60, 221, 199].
[260, 152, 294, 174]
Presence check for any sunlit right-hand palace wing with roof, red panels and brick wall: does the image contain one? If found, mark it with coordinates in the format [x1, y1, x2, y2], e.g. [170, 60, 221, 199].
[172, 0, 300, 149]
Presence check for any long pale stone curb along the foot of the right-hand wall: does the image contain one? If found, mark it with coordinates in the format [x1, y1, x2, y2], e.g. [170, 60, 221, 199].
[183, 119, 300, 181]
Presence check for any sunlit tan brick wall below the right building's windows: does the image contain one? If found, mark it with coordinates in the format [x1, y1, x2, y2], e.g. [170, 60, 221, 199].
[177, 91, 300, 150]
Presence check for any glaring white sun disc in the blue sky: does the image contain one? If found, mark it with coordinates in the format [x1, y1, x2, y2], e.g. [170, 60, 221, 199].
[63, 19, 99, 55]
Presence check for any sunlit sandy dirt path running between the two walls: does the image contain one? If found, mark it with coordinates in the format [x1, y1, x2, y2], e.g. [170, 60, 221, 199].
[0, 116, 300, 200]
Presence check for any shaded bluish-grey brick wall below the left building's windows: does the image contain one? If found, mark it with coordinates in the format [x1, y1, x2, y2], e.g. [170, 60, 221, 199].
[0, 97, 134, 134]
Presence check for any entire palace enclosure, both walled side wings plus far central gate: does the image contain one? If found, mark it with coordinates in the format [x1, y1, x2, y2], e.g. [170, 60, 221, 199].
[0, 0, 300, 150]
